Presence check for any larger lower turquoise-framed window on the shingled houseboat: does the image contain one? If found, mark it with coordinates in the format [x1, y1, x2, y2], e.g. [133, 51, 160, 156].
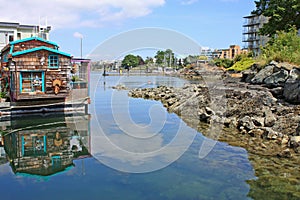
[20, 72, 45, 93]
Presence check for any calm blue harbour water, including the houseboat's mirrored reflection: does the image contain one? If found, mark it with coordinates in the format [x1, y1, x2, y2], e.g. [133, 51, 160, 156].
[0, 74, 256, 200]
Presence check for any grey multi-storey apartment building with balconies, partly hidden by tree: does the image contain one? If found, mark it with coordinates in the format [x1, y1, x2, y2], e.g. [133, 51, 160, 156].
[243, 15, 268, 56]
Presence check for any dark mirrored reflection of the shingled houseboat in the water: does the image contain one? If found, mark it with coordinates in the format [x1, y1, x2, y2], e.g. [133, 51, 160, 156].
[2, 115, 90, 176]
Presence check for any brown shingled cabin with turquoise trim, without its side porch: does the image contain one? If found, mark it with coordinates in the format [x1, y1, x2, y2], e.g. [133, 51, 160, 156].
[1, 37, 71, 101]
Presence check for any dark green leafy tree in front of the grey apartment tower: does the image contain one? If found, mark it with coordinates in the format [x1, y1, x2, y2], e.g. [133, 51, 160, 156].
[252, 0, 300, 36]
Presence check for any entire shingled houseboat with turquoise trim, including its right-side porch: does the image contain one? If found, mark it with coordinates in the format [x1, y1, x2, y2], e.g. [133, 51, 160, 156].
[1, 37, 90, 115]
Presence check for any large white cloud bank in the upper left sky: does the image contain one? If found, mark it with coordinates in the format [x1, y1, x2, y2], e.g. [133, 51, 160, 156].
[0, 0, 165, 28]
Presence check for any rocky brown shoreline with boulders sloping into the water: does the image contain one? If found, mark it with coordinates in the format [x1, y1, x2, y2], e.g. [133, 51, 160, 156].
[129, 62, 300, 159]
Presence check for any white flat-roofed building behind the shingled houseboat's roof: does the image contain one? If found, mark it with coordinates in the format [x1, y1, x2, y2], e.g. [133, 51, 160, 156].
[0, 22, 51, 50]
